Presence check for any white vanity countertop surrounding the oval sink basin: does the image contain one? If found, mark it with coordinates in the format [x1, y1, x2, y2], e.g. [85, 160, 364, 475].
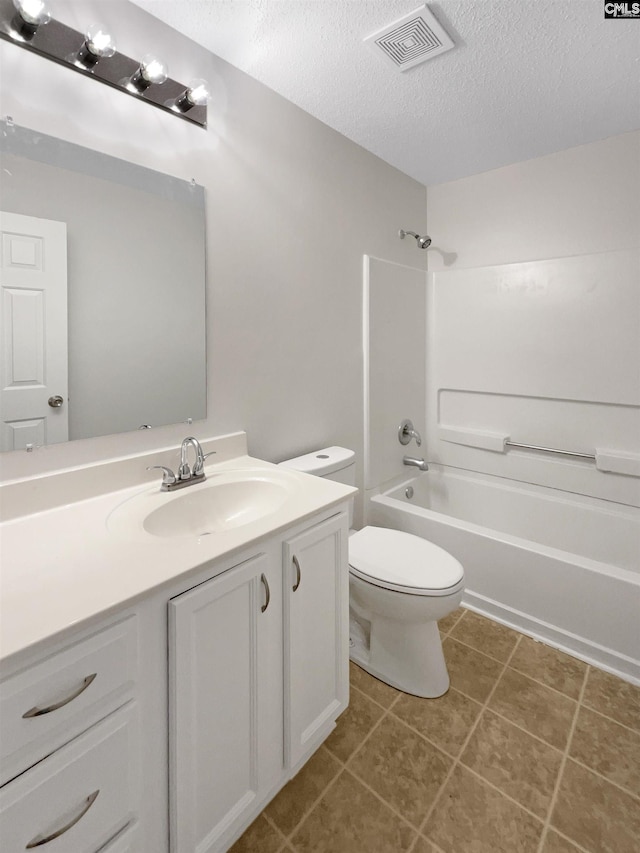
[0, 446, 356, 661]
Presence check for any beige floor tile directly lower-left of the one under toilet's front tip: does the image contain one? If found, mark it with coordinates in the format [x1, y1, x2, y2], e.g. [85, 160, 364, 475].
[349, 717, 453, 827]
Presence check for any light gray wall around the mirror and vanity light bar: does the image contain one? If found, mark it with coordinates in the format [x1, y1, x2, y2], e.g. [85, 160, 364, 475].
[0, 2, 426, 500]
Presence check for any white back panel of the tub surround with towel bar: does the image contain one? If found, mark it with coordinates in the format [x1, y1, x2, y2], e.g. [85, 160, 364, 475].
[424, 249, 640, 506]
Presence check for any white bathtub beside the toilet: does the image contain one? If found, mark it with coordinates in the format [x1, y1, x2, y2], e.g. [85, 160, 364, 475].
[367, 465, 640, 684]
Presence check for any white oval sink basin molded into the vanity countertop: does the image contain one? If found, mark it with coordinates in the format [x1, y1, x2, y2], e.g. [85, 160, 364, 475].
[107, 471, 293, 539]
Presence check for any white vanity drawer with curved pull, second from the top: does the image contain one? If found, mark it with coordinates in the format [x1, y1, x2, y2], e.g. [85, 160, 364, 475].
[0, 702, 140, 853]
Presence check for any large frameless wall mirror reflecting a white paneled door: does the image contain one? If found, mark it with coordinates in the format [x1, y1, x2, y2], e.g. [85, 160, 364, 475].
[0, 121, 206, 450]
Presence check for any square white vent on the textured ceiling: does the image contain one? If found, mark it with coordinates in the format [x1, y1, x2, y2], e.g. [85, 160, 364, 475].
[364, 6, 455, 71]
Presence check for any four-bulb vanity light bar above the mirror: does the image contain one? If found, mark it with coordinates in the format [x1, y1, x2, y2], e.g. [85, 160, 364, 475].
[0, 0, 210, 127]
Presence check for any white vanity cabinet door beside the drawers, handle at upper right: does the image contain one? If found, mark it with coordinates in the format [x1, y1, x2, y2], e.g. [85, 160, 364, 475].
[169, 554, 283, 853]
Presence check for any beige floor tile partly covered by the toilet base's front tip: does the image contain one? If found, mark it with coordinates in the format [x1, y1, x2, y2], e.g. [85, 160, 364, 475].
[392, 687, 482, 756]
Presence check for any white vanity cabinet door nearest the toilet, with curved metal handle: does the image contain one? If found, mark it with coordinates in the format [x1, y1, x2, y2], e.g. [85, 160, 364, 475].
[283, 512, 349, 769]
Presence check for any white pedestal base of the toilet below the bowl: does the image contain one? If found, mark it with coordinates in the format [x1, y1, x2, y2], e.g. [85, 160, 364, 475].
[349, 614, 449, 699]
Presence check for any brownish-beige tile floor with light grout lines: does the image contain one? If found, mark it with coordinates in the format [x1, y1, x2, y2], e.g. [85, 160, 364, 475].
[232, 609, 640, 853]
